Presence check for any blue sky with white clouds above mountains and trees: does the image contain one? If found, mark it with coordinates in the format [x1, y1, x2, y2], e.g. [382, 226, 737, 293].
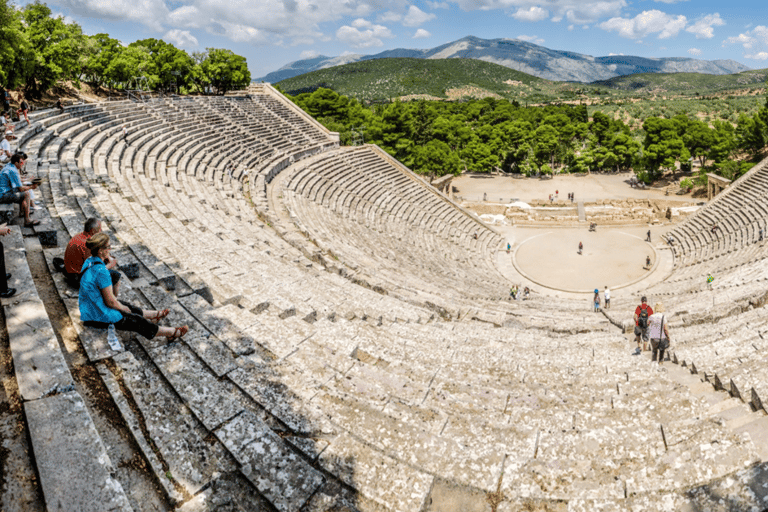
[34, 0, 768, 78]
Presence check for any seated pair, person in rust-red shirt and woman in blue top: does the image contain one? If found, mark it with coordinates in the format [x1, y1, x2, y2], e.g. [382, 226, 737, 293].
[54, 218, 189, 340]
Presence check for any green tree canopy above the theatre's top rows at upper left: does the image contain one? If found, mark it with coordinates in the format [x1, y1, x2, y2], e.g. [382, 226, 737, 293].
[0, 0, 251, 98]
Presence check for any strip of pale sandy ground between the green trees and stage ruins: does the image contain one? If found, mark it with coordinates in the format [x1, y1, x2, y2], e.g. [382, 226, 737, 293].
[453, 173, 701, 203]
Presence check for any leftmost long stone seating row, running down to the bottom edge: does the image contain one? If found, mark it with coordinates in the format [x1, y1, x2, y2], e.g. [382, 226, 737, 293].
[3, 227, 132, 511]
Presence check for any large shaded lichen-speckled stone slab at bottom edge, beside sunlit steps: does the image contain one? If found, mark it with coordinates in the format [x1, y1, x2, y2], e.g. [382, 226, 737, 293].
[216, 411, 323, 511]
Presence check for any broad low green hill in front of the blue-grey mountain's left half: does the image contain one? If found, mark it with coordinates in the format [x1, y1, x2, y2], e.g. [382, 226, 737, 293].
[277, 58, 562, 101]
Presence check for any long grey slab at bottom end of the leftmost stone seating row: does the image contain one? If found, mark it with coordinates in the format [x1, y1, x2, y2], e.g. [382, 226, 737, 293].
[24, 391, 132, 512]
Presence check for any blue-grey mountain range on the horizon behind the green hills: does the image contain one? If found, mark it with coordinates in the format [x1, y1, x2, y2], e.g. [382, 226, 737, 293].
[256, 36, 751, 83]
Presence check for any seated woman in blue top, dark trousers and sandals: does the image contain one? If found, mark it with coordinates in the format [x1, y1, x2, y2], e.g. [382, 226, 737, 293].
[79, 233, 189, 340]
